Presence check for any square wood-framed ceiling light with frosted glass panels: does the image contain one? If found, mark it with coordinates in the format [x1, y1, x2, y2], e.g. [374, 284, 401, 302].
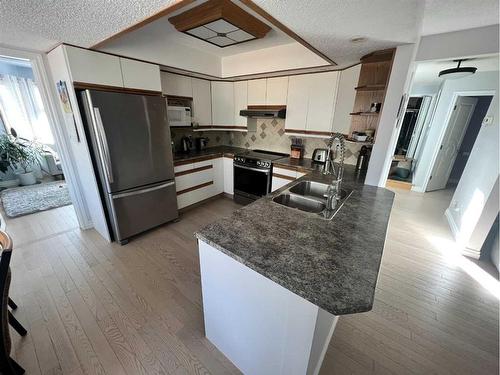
[168, 0, 271, 48]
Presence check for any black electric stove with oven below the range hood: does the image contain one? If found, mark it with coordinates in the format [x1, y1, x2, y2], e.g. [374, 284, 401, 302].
[233, 150, 289, 204]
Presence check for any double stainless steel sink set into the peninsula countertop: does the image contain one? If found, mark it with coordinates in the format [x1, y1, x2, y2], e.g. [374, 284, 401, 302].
[273, 180, 351, 220]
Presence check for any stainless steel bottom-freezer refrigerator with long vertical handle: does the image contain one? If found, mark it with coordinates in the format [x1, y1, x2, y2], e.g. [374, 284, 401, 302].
[79, 90, 178, 244]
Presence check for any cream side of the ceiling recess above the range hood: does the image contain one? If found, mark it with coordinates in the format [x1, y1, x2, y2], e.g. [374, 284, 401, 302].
[222, 42, 329, 78]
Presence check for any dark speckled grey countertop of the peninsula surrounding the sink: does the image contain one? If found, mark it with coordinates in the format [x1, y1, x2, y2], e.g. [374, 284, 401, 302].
[195, 166, 394, 315]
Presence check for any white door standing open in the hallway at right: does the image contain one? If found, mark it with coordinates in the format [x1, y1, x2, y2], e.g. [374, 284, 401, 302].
[426, 96, 477, 191]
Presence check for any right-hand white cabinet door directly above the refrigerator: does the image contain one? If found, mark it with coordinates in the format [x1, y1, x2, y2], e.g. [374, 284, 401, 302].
[120, 57, 161, 91]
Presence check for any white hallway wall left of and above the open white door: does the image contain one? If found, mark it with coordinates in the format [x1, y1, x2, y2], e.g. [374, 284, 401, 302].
[413, 71, 498, 192]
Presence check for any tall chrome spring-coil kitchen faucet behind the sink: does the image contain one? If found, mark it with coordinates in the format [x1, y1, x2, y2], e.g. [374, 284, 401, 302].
[323, 133, 345, 210]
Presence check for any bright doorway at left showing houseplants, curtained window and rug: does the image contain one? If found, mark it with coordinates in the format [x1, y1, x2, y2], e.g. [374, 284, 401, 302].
[0, 55, 78, 232]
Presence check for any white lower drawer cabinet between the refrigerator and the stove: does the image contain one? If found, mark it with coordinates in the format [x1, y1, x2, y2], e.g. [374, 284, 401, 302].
[174, 158, 233, 209]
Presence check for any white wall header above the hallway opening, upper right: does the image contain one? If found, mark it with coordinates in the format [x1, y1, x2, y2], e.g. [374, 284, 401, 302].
[416, 25, 499, 61]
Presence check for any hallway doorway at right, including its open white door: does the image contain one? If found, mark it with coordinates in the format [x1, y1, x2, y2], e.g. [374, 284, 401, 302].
[426, 95, 493, 191]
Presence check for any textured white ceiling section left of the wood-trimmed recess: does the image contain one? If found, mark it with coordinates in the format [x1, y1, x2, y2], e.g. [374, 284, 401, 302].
[0, 0, 180, 51]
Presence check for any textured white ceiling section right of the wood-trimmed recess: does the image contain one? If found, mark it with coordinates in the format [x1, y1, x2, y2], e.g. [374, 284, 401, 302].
[250, 0, 423, 65]
